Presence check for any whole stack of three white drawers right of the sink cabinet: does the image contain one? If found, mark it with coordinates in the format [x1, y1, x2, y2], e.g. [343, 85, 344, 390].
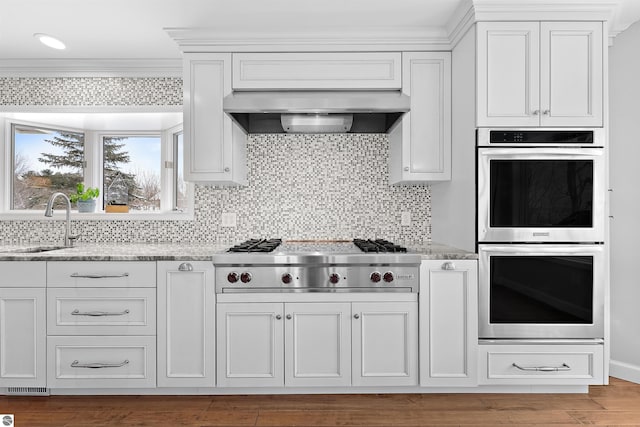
[46, 261, 156, 389]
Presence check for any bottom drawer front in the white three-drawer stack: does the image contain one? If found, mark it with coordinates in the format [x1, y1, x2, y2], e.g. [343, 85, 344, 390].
[47, 337, 156, 388]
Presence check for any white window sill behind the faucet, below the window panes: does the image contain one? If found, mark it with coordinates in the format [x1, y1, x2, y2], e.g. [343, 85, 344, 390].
[0, 209, 194, 221]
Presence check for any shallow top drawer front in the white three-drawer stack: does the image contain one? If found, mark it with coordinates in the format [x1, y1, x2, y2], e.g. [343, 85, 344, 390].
[47, 261, 156, 288]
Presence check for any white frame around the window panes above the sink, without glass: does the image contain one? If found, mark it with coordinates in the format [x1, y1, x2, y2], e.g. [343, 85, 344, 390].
[0, 115, 194, 220]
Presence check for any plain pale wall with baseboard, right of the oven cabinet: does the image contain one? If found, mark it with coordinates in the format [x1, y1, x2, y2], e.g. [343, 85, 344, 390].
[609, 19, 640, 383]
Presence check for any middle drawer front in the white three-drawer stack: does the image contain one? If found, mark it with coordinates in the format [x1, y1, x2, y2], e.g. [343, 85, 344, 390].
[47, 288, 156, 335]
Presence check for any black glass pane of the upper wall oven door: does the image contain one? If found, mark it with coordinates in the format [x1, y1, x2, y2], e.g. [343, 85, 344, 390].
[489, 160, 593, 228]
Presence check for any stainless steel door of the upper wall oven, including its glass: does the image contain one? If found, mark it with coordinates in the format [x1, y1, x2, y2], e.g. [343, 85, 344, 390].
[478, 147, 605, 243]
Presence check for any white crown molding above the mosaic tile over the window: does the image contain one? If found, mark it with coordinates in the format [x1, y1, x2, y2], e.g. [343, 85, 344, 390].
[0, 59, 182, 77]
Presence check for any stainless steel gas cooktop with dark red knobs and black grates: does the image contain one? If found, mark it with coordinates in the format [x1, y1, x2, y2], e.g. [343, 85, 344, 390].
[213, 239, 421, 293]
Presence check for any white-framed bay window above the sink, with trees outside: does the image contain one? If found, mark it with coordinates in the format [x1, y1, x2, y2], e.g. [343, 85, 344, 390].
[0, 112, 193, 219]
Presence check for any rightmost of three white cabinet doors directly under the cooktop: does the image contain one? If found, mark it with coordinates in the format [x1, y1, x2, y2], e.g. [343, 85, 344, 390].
[352, 302, 418, 386]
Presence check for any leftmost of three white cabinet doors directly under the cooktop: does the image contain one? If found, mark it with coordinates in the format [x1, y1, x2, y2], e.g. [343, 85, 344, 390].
[217, 303, 284, 387]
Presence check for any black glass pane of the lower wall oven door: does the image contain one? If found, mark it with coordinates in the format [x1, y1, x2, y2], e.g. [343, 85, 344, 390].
[489, 256, 594, 324]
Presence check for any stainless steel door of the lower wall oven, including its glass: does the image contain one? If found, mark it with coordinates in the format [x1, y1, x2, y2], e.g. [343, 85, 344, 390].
[478, 244, 605, 338]
